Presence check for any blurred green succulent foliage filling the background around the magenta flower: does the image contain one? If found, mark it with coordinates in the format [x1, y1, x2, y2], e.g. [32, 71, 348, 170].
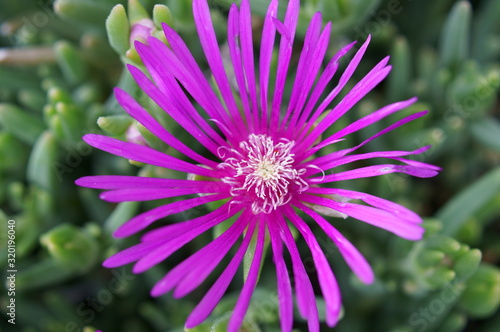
[0, 0, 500, 332]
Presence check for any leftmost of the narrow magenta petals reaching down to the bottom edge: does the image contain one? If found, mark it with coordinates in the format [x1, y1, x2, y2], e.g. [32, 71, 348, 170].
[186, 220, 255, 328]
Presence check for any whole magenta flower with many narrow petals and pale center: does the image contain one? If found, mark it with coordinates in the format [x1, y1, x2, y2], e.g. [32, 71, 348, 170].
[77, 0, 438, 332]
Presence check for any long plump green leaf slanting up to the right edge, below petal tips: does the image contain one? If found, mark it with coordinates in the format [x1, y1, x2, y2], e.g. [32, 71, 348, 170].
[436, 167, 500, 236]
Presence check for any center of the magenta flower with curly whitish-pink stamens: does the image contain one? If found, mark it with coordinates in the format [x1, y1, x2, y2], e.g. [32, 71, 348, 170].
[219, 134, 309, 214]
